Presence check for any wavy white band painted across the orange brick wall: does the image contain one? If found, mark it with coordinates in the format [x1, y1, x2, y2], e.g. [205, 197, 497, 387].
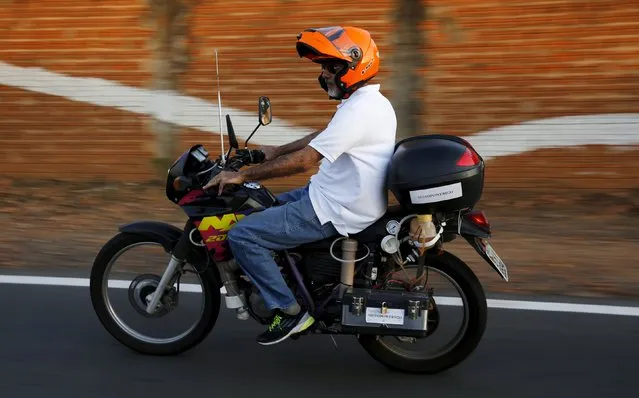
[0, 61, 639, 159]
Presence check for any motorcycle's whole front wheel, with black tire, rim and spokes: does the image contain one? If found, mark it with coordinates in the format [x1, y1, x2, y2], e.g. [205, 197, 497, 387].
[90, 233, 221, 355]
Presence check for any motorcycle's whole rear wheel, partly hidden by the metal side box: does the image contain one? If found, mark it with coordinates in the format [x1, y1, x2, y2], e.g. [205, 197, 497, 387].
[358, 252, 488, 374]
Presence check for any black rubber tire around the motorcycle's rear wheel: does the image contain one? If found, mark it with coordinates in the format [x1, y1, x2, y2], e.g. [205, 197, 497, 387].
[358, 252, 488, 374]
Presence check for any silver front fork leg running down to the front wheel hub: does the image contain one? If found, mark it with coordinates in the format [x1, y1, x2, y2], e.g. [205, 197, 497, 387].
[146, 220, 196, 314]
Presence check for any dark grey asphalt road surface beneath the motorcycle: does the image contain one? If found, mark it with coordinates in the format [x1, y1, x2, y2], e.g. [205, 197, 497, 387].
[0, 285, 639, 398]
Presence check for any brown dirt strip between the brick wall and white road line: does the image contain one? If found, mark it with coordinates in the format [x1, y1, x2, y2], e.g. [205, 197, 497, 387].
[0, 179, 639, 298]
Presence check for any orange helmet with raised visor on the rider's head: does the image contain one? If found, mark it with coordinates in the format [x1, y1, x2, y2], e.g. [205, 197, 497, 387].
[296, 26, 379, 96]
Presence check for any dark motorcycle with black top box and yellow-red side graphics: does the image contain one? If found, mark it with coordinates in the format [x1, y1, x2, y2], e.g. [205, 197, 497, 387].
[90, 97, 508, 374]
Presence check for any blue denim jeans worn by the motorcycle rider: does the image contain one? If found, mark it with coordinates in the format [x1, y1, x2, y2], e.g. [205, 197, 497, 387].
[227, 185, 338, 310]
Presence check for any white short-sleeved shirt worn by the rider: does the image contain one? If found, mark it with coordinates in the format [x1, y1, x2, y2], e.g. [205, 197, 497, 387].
[309, 84, 397, 236]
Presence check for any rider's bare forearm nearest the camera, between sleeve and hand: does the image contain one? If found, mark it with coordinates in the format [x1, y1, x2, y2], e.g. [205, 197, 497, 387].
[240, 148, 320, 181]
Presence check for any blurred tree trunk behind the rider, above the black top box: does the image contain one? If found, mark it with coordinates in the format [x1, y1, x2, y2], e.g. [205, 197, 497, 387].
[390, 0, 426, 139]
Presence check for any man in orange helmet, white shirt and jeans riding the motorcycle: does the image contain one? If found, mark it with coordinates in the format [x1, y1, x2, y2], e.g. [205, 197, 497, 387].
[204, 26, 397, 345]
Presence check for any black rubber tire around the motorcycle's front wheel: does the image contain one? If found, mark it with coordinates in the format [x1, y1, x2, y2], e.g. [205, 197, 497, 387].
[90, 232, 221, 355]
